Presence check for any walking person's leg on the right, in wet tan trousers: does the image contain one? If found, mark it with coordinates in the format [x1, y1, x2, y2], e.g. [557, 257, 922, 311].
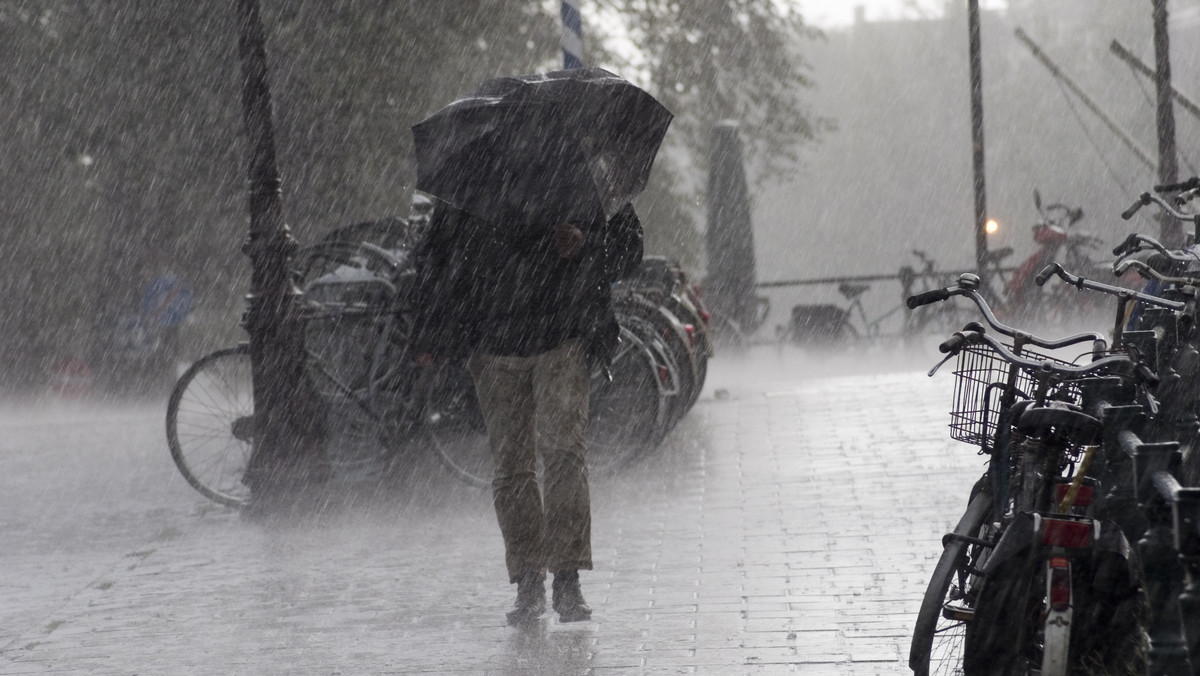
[533, 340, 592, 622]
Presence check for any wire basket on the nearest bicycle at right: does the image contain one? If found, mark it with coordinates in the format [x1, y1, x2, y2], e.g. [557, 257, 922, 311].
[950, 343, 1081, 447]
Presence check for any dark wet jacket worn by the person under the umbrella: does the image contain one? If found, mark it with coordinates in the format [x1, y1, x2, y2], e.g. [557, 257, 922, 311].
[409, 203, 642, 367]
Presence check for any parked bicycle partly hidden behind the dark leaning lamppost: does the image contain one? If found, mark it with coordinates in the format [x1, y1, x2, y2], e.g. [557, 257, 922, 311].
[167, 240, 414, 507]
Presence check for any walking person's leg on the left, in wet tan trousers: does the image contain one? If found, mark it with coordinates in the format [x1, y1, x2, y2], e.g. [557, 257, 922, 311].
[468, 353, 546, 624]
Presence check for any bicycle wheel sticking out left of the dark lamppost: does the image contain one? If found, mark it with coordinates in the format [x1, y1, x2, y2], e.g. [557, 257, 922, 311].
[167, 346, 254, 507]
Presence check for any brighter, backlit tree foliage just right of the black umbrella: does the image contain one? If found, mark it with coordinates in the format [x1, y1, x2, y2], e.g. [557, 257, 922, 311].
[592, 0, 830, 267]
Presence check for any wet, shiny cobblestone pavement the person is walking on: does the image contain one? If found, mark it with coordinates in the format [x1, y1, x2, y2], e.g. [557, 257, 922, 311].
[0, 349, 982, 675]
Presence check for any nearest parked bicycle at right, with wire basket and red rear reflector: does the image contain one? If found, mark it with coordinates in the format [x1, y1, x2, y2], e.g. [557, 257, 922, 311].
[907, 275, 1153, 676]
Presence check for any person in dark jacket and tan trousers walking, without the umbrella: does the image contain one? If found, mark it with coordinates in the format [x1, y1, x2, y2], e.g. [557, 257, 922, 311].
[410, 202, 642, 626]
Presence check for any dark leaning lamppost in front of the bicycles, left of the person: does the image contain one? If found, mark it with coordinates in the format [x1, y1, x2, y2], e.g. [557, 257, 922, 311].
[238, 0, 314, 496]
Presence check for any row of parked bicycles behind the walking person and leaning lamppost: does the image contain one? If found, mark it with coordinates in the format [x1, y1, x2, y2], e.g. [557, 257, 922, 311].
[167, 214, 713, 507]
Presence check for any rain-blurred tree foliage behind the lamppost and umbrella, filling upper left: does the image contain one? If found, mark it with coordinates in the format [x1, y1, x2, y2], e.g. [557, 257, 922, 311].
[0, 0, 816, 389]
